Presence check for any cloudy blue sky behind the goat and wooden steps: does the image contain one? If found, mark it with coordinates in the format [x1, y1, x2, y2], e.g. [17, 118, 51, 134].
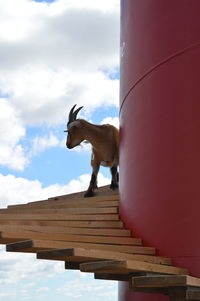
[0, 0, 119, 301]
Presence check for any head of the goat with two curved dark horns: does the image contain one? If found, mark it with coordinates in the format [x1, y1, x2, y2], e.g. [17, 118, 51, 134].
[64, 105, 84, 148]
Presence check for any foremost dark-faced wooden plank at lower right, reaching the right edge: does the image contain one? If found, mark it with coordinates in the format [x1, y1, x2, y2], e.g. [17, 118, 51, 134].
[131, 275, 200, 288]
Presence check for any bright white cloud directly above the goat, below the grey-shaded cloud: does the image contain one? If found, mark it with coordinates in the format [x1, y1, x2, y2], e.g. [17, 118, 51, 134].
[5, 68, 119, 125]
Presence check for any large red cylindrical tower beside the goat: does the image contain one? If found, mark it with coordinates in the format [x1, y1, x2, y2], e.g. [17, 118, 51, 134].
[119, 0, 200, 301]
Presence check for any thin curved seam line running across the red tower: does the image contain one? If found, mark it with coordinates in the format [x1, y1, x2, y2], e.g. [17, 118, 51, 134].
[119, 42, 200, 113]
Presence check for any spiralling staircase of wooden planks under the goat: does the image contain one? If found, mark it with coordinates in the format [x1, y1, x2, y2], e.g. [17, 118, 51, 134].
[0, 186, 200, 300]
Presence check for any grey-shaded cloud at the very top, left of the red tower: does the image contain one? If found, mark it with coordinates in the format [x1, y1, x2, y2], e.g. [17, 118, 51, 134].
[0, 0, 119, 70]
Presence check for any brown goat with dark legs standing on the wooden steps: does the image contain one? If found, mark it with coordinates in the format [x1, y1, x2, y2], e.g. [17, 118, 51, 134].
[64, 105, 119, 197]
